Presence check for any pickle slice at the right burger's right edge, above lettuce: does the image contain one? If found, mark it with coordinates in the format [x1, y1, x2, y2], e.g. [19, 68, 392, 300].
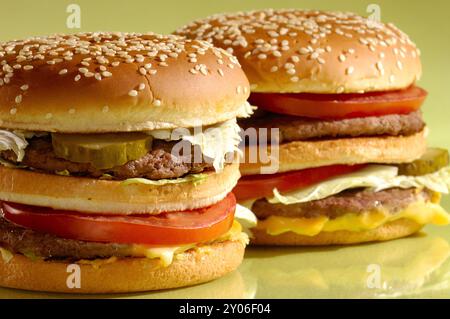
[398, 147, 449, 176]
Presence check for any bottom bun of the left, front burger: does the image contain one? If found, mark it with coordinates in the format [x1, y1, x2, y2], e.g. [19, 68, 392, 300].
[0, 241, 245, 294]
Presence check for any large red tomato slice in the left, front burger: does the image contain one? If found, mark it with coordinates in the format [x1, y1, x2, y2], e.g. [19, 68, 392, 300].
[1, 193, 236, 245]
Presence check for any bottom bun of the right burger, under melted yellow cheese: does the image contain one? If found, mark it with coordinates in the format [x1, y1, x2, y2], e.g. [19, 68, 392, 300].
[251, 218, 423, 246]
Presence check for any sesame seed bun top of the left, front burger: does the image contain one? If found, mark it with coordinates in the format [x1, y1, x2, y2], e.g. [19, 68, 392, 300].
[0, 33, 249, 133]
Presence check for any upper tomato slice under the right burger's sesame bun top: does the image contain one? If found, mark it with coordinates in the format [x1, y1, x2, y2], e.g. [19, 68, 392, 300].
[249, 86, 428, 119]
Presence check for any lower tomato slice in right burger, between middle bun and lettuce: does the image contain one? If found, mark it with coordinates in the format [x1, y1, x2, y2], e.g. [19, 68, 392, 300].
[233, 164, 366, 200]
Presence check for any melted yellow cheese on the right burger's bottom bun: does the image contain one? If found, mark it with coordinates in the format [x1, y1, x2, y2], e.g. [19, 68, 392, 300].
[256, 201, 450, 236]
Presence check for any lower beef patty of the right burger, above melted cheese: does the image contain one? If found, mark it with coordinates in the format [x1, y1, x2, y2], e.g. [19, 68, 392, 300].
[252, 188, 432, 219]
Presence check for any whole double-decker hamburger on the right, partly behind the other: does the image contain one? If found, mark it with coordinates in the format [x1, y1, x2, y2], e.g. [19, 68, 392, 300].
[175, 9, 449, 245]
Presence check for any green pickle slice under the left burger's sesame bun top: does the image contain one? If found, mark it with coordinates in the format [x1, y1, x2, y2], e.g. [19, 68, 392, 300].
[52, 133, 153, 169]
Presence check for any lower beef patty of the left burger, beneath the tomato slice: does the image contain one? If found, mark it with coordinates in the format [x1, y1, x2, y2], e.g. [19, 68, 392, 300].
[0, 215, 132, 260]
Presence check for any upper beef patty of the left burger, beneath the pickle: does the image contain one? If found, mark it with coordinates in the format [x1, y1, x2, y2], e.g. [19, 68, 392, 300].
[0, 137, 212, 180]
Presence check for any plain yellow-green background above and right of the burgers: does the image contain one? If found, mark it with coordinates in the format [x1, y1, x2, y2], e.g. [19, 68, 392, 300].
[0, 0, 450, 148]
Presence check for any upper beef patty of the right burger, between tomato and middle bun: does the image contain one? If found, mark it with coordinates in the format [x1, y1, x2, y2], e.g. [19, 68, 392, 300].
[239, 111, 425, 143]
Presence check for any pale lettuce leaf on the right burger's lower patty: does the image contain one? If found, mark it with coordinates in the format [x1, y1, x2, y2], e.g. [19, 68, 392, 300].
[268, 165, 450, 205]
